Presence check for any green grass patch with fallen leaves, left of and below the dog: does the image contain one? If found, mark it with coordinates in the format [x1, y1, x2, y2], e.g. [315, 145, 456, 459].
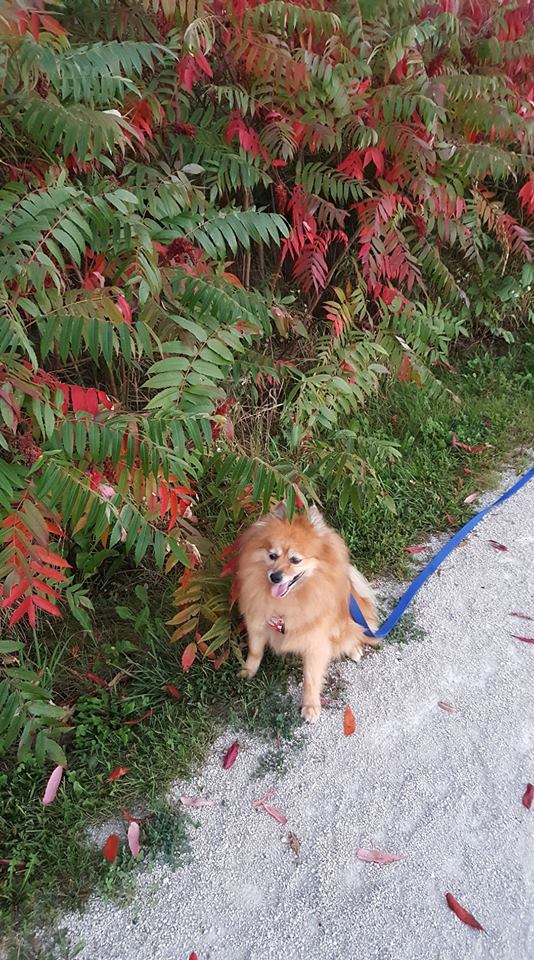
[0, 582, 300, 928]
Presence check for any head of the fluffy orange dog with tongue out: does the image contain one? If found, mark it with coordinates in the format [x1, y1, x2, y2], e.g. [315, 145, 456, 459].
[247, 504, 329, 599]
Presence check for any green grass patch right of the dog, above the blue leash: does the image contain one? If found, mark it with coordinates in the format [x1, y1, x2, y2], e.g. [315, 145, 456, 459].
[325, 344, 534, 576]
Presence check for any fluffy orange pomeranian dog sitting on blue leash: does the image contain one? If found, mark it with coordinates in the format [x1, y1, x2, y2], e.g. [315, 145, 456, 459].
[237, 503, 379, 723]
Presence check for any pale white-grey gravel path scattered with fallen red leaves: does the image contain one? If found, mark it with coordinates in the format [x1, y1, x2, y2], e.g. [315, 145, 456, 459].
[62, 474, 534, 960]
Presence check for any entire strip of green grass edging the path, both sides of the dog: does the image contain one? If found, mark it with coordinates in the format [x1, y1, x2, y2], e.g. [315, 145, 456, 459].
[0, 338, 534, 944]
